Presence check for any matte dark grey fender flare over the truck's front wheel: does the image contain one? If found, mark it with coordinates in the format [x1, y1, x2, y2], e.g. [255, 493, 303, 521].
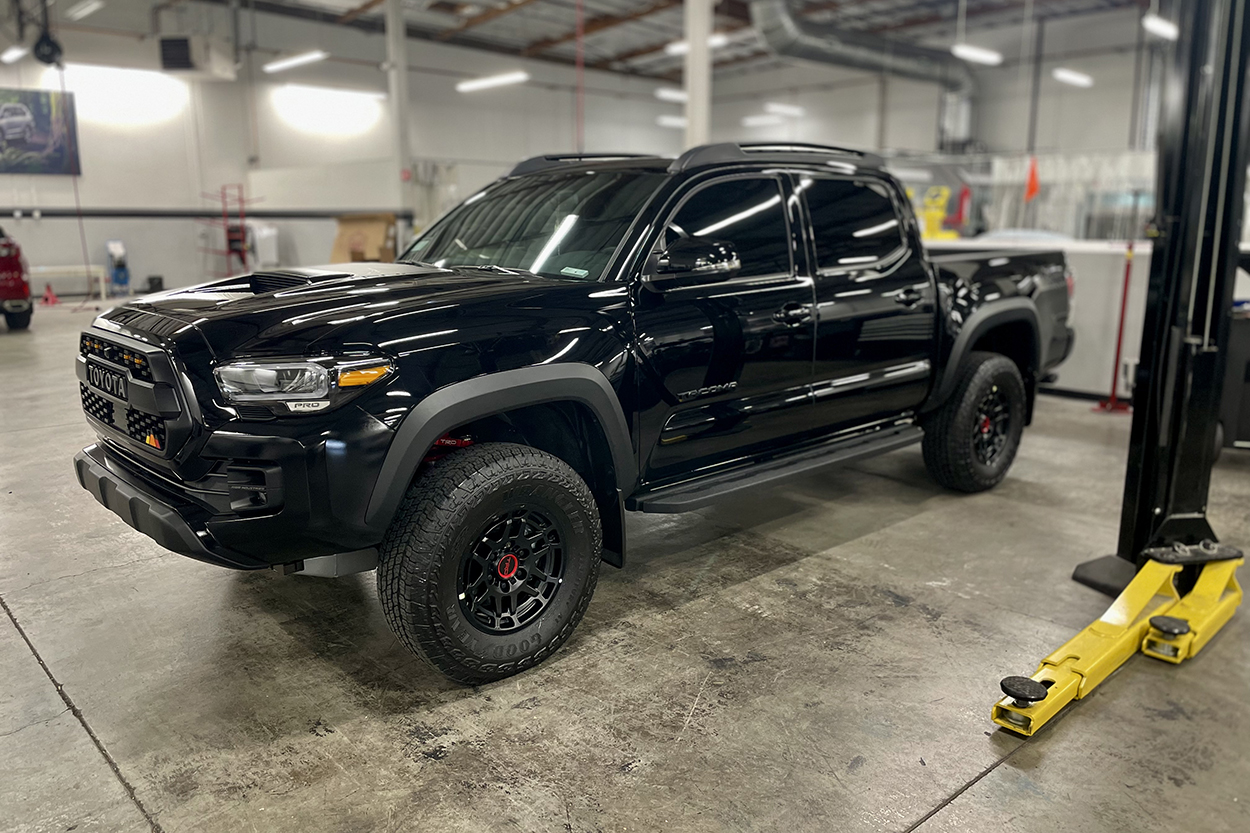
[365, 361, 638, 527]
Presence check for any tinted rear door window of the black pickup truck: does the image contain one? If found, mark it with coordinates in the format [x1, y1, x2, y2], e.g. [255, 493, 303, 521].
[801, 179, 903, 270]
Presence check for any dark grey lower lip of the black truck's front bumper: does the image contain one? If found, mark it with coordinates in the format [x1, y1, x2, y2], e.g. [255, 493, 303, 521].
[74, 445, 270, 570]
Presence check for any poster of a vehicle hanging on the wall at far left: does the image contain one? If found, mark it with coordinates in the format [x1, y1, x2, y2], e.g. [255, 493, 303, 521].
[0, 89, 83, 175]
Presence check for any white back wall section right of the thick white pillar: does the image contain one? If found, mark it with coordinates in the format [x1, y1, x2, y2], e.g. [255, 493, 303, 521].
[713, 9, 1140, 151]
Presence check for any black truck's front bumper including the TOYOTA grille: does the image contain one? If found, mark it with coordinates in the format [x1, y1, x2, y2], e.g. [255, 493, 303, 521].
[74, 320, 394, 569]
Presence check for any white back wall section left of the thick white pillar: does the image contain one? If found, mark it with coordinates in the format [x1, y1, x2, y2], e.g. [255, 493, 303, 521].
[0, 4, 681, 290]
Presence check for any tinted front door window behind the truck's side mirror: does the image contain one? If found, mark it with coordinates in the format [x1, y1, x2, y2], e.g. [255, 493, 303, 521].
[665, 179, 790, 278]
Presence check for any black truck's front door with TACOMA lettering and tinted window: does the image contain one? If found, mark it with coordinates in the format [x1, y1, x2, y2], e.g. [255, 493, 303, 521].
[634, 174, 815, 484]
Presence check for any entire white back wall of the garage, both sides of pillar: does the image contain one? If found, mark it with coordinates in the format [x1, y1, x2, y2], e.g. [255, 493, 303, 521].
[0, 3, 1138, 285]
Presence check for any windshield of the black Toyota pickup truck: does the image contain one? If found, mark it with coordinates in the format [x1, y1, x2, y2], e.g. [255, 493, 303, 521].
[400, 171, 665, 280]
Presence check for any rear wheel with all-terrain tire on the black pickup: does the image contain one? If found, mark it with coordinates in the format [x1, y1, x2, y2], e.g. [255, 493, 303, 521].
[923, 351, 1028, 492]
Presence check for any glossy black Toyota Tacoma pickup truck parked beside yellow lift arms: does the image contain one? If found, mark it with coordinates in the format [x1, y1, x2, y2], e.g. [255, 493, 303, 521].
[75, 144, 1073, 683]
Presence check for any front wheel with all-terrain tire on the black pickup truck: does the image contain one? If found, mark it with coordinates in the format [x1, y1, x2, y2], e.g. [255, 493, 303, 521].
[378, 443, 603, 685]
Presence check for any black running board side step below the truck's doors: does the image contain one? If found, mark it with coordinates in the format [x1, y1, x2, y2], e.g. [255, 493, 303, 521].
[625, 425, 925, 514]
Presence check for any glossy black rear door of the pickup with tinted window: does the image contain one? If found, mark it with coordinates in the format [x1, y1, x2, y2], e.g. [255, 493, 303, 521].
[796, 174, 936, 429]
